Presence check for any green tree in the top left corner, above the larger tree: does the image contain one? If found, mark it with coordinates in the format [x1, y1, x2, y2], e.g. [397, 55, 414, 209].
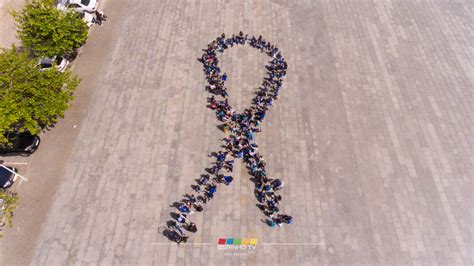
[12, 0, 88, 57]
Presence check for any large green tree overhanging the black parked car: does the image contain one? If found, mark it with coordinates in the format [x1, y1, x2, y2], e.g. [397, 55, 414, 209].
[0, 47, 79, 144]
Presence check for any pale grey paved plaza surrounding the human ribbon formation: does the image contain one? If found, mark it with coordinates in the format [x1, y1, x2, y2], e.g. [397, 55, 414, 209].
[4, 0, 474, 265]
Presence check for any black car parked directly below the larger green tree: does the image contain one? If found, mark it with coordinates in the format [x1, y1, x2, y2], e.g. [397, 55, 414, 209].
[0, 132, 41, 155]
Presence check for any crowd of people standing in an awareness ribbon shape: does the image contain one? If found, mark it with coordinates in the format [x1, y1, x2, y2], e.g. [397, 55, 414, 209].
[167, 32, 293, 244]
